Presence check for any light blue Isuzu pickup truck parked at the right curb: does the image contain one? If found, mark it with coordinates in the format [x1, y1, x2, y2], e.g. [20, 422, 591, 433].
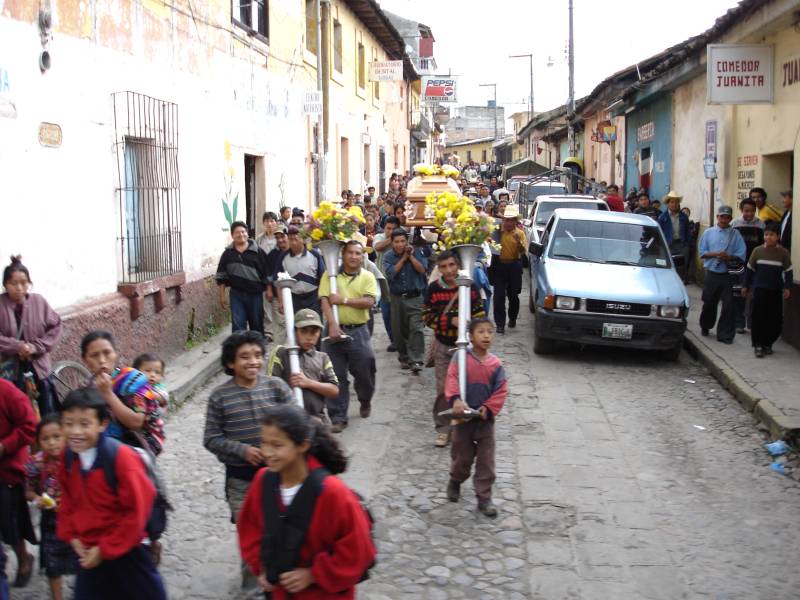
[529, 208, 689, 360]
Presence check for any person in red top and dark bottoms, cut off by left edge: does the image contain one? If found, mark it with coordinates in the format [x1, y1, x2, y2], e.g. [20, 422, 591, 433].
[0, 379, 36, 600]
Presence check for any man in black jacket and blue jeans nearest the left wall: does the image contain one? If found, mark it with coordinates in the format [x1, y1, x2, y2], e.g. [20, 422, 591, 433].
[215, 221, 269, 335]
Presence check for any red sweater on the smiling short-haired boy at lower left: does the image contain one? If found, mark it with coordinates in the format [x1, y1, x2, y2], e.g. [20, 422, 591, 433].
[56, 436, 156, 559]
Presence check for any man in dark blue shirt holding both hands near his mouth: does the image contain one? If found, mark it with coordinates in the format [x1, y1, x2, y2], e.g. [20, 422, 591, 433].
[383, 229, 428, 374]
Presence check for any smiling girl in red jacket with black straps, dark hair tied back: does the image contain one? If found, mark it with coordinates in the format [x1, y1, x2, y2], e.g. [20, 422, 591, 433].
[236, 405, 376, 600]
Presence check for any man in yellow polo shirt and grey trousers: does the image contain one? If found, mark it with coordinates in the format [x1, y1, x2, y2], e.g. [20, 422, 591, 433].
[319, 240, 378, 433]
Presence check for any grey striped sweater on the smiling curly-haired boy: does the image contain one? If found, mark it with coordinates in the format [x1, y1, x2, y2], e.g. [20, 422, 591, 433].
[203, 375, 294, 467]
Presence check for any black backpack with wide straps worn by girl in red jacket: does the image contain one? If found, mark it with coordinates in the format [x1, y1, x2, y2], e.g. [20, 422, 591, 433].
[261, 468, 375, 585]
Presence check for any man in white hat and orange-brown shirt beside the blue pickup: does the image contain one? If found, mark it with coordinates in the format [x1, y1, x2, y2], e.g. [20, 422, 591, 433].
[489, 204, 528, 333]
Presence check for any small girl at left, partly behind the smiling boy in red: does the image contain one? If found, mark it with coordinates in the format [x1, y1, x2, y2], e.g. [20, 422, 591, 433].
[25, 413, 78, 600]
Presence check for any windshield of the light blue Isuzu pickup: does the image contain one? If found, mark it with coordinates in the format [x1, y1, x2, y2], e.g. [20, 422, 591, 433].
[549, 219, 672, 269]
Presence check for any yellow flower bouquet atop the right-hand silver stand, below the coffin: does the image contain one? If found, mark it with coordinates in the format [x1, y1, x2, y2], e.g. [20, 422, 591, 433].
[425, 192, 497, 251]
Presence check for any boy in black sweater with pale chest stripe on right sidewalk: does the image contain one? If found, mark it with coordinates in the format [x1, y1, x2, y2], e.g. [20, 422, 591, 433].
[742, 222, 792, 358]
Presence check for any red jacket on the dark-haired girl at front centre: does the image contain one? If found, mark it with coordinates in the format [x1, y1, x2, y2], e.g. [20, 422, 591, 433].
[236, 457, 375, 600]
